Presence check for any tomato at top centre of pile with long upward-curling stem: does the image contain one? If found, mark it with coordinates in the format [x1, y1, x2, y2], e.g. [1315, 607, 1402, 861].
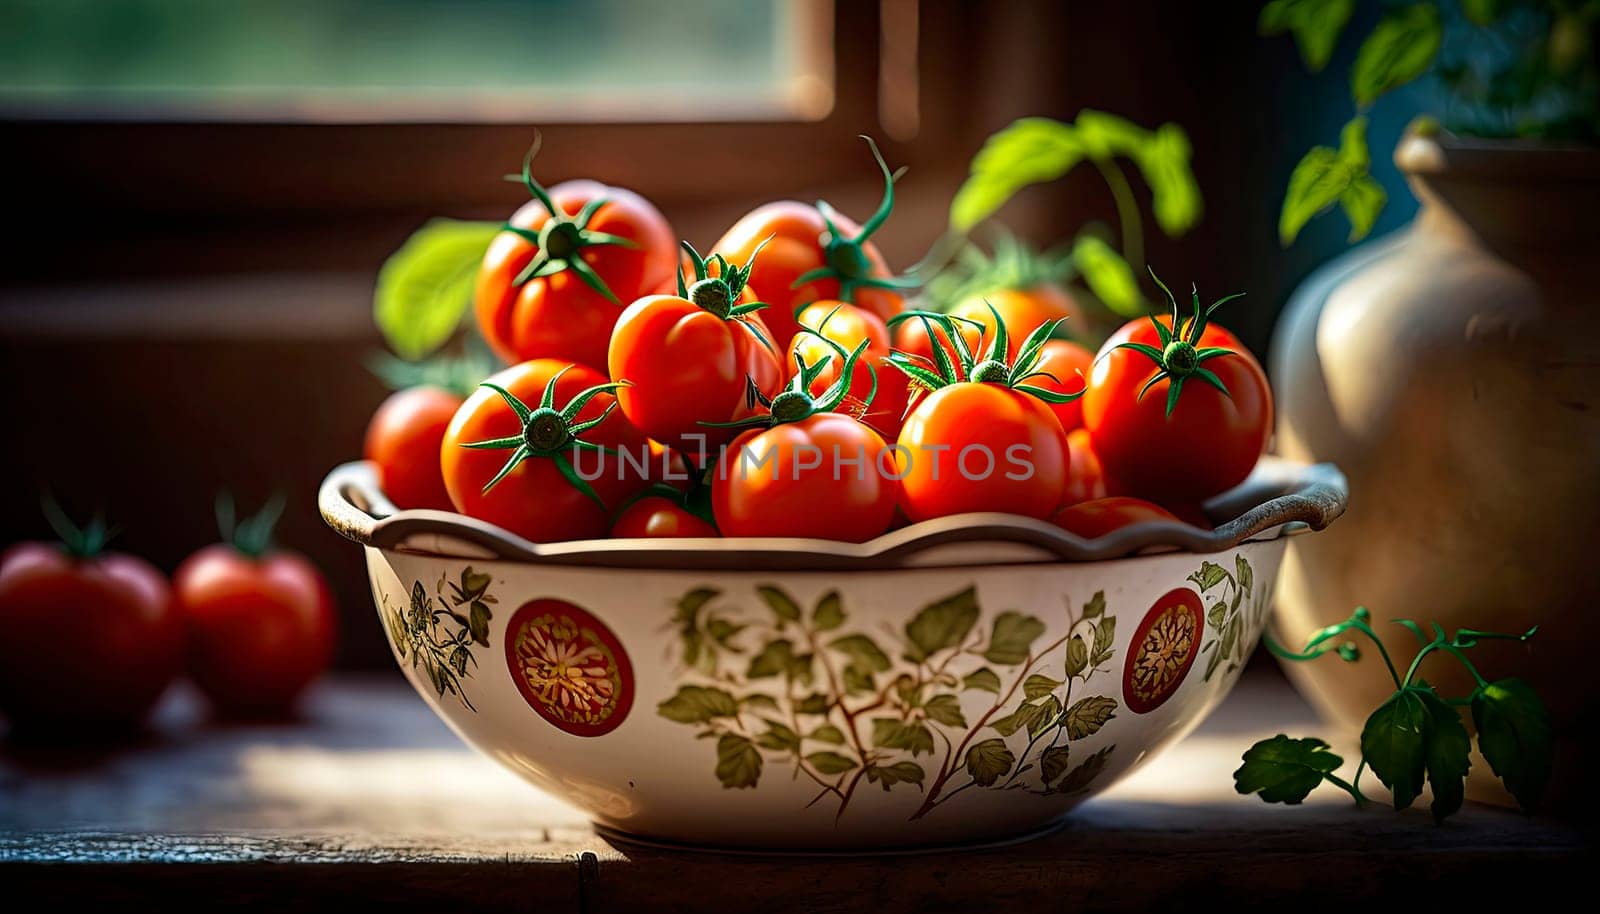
[715, 138, 906, 349]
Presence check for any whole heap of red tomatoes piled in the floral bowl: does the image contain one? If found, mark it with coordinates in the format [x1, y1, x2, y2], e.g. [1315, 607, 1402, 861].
[366, 139, 1272, 543]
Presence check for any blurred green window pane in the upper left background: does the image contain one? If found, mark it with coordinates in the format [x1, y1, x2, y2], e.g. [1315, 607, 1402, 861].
[0, 0, 832, 122]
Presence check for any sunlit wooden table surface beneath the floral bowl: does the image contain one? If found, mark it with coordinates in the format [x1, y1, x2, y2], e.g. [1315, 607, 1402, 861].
[0, 675, 1590, 914]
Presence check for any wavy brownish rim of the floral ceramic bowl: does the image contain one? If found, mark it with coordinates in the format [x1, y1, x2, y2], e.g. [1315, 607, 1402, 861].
[317, 456, 1349, 571]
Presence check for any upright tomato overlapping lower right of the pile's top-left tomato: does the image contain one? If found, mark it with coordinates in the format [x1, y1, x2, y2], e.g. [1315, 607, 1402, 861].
[606, 242, 784, 464]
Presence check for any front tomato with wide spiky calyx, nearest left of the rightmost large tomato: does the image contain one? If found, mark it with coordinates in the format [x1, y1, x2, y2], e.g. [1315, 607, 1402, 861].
[894, 307, 1077, 522]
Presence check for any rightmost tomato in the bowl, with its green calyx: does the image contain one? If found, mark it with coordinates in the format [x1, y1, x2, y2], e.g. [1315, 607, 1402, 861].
[1083, 280, 1272, 503]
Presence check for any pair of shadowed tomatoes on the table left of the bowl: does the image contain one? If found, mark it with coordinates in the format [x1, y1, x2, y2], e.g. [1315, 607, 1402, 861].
[0, 501, 336, 740]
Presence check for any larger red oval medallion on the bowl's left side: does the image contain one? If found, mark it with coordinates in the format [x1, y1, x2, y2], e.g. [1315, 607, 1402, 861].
[506, 599, 634, 736]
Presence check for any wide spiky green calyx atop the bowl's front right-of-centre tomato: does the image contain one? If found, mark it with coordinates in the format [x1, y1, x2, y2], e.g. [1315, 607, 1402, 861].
[888, 303, 1083, 403]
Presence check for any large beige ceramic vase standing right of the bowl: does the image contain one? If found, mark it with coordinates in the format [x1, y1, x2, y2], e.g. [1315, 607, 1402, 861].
[1274, 134, 1600, 812]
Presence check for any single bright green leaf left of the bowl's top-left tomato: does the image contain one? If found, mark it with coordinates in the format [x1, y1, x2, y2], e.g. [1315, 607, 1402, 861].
[373, 219, 501, 360]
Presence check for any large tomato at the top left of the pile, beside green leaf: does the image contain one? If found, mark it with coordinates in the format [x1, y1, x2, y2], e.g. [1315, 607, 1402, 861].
[474, 152, 678, 368]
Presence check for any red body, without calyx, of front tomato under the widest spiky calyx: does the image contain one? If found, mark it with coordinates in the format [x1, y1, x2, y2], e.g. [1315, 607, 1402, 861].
[894, 381, 1067, 522]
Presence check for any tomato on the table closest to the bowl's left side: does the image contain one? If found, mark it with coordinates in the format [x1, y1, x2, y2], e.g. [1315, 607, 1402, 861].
[173, 499, 338, 716]
